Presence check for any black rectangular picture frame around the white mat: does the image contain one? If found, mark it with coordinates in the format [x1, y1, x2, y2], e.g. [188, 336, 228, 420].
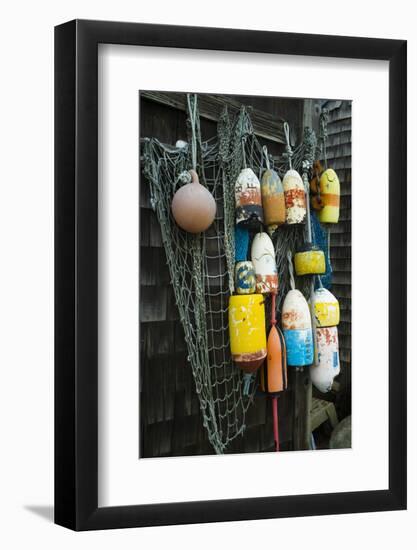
[55, 20, 407, 530]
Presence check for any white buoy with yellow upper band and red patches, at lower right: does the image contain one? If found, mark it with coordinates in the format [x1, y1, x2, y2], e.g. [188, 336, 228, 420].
[310, 287, 340, 393]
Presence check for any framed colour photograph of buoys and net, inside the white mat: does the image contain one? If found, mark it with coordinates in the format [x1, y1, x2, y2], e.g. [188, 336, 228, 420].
[138, 90, 352, 459]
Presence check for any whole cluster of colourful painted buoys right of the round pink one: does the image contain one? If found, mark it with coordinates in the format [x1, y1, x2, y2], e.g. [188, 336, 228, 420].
[229, 111, 340, 450]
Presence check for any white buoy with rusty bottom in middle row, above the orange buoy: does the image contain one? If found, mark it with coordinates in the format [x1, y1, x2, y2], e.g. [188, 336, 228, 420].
[251, 232, 278, 294]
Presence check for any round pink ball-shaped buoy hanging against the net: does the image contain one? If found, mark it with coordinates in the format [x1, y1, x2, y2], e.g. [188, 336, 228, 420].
[171, 170, 216, 233]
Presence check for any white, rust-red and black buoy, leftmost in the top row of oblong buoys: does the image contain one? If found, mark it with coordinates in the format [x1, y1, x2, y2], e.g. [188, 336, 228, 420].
[235, 168, 263, 228]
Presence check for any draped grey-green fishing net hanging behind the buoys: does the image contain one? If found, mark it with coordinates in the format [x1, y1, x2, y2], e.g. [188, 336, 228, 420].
[143, 95, 309, 454]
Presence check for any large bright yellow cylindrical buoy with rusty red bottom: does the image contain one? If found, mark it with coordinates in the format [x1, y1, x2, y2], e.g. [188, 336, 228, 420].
[229, 294, 267, 372]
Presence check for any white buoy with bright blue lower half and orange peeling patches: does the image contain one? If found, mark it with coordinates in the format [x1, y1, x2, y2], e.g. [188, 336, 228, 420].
[282, 289, 314, 367]
